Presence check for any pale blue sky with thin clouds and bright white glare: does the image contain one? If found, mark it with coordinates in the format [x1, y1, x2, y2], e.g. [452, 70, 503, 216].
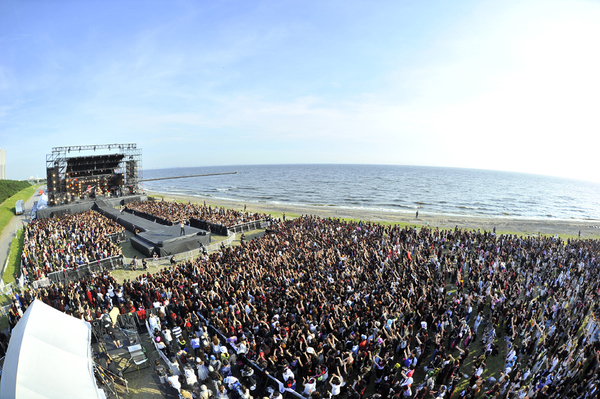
[0, 0, 600, 181]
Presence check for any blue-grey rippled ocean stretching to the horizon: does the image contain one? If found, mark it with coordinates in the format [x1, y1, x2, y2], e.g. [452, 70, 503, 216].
[143, 164, 600, 220]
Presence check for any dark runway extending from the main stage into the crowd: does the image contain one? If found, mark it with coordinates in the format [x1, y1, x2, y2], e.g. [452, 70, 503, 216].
[97, 201, 210, 257]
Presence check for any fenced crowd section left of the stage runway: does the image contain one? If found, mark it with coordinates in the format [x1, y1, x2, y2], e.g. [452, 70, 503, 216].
[21, 211, 125, 281]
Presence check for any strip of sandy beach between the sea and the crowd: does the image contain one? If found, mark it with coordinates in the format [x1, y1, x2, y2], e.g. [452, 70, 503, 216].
[145, 190, 600, 238]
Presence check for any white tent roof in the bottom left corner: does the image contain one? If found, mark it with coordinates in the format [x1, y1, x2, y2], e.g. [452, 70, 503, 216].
[0, 300, 101, 399]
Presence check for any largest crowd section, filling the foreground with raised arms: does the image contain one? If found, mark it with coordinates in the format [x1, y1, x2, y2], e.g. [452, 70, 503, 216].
[4, 216, 600, 399]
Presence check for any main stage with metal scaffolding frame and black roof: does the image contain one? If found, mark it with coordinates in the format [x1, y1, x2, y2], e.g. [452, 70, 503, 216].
[46, 143, 142, 205]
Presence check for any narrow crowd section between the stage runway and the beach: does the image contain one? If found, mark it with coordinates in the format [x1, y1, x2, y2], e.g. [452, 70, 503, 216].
[126, 200, 268, 227]
